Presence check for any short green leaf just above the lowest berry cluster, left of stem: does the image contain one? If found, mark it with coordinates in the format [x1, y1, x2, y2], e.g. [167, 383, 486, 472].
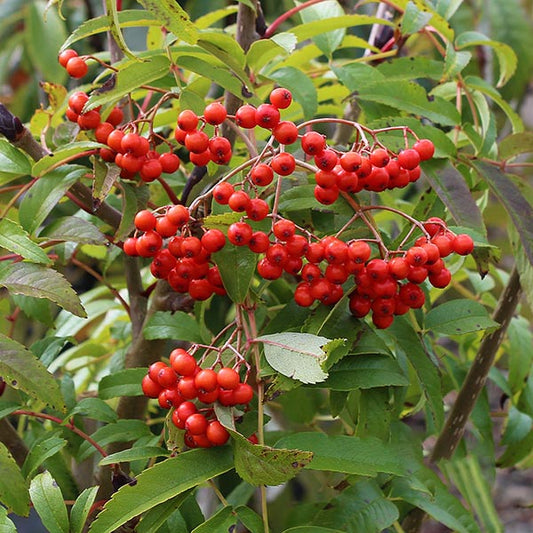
[144, 311, 206, 343]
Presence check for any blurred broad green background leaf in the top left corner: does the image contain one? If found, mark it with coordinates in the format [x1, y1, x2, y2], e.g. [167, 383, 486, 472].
[24, 0, 67, 83]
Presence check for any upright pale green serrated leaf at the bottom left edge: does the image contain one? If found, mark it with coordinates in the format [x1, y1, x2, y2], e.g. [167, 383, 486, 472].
[30, 472, 69, 533]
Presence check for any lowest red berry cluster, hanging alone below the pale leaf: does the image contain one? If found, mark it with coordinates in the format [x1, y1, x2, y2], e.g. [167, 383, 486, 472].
[142, 348, 253, 448]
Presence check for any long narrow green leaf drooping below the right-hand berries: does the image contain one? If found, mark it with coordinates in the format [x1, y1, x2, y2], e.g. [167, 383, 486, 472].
[386, 317, 444, 429]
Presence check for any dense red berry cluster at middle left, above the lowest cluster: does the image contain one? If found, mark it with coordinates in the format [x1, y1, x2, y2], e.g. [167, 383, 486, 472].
[123, 205, 226, 300]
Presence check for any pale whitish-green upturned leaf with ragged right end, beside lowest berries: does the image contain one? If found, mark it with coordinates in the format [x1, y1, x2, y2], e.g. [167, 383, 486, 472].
[256, 332, 331, 383]
